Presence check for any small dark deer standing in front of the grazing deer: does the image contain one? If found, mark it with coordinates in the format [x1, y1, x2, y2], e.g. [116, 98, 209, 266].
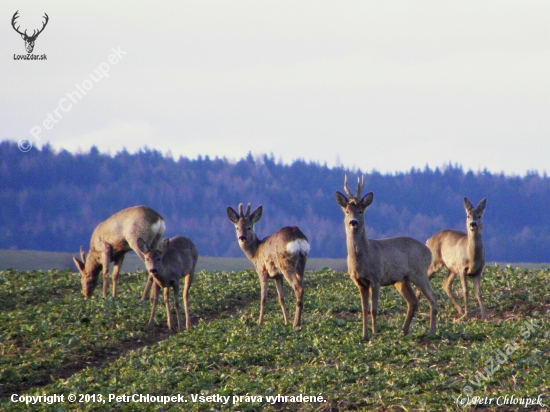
[138, 236, 198, 332]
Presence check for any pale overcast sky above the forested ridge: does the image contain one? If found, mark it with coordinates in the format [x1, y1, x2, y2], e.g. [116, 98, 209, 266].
[0, 0, 550, 175]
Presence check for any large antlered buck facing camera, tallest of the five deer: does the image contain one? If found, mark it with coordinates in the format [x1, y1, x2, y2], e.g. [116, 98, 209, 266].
[336, 176, 437, 341]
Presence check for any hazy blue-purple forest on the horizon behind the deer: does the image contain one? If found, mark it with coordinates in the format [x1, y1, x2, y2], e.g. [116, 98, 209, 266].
[0, 141, 550, 262]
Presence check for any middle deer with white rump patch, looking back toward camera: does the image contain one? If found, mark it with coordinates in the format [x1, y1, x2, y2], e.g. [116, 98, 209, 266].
[227, 203, 309, 328]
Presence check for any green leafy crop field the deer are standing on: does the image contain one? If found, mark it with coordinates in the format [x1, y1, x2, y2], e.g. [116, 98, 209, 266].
[0, 266, 550, 411]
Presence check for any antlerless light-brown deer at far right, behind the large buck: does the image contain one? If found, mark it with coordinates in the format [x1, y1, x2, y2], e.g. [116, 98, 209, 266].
[426, 197, 486, 319]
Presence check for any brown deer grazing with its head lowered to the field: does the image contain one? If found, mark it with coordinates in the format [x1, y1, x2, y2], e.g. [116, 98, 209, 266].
[73, 206, 166, 300]
